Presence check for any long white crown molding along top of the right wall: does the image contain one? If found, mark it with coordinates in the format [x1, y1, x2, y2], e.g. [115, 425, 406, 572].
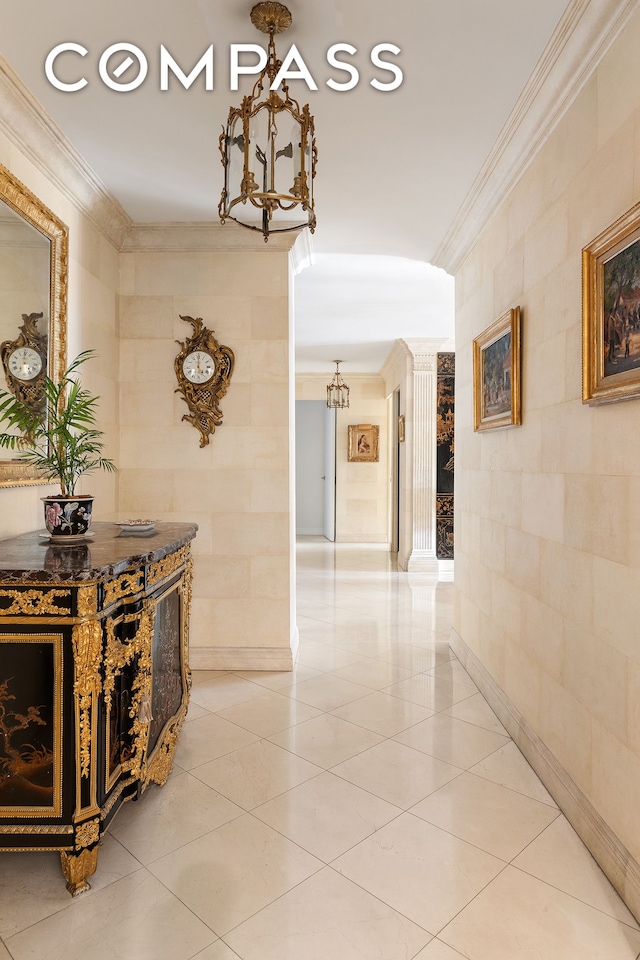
[431, 0, 639, 274]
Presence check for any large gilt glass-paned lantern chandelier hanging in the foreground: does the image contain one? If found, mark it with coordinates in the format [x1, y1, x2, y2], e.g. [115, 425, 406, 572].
[218, 0, 318, 243]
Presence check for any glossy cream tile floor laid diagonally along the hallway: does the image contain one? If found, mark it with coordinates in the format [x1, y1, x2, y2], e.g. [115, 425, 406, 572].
[0, 541, 640, 960]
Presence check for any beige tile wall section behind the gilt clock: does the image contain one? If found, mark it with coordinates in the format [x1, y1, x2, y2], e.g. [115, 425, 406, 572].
[119, 249, 294, 669]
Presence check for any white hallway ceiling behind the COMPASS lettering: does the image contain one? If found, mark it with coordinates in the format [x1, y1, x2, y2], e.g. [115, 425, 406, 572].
[2, 0, 568, 373]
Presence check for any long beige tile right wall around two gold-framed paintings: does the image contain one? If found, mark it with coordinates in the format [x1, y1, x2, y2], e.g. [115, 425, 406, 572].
[455, 5, 640, 860]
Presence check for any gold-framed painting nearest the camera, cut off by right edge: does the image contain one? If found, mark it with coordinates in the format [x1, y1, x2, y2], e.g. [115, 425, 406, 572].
[582, 203, 640, 404]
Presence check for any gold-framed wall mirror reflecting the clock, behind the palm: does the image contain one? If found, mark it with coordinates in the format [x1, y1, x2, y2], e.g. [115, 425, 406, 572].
[0, 165, 69, 487]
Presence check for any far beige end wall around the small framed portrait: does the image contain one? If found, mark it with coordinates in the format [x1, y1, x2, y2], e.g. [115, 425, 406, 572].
[296, 374, 389, 543]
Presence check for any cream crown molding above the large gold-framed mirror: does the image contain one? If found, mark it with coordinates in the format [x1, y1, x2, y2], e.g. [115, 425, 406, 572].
[0, 55, 132, 249]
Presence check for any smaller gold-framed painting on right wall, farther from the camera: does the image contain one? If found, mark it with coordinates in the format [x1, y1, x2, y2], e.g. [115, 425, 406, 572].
[473, 307, 522, 430]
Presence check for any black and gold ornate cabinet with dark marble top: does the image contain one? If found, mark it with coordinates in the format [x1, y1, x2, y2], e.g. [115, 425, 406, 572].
[0, 523, 197, 895]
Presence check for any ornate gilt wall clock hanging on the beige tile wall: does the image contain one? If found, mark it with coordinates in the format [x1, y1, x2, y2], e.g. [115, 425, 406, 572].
[174, 315, 235, 447]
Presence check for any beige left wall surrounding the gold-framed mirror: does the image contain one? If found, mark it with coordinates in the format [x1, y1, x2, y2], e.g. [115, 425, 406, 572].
[0, 134, 120, 539]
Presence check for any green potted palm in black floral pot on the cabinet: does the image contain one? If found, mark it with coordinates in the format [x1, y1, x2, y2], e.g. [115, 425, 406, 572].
[0, 350, 116, 538]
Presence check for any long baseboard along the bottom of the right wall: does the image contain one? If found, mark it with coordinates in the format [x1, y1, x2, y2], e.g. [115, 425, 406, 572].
[450, 630, 640, 919]
